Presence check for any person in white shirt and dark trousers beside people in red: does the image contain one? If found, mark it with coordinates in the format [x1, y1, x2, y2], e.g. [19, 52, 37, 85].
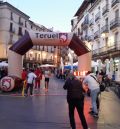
[25, 69, 37, 96]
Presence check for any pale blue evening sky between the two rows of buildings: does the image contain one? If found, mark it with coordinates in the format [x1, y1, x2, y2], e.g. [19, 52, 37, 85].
[4, 0, 83, 32]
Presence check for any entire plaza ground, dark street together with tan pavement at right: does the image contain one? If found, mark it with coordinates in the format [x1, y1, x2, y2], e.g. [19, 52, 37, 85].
[0, 77, 120, 129]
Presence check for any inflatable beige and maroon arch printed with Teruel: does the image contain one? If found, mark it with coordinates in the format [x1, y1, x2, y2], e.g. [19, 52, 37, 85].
[0, 31, 91, 91]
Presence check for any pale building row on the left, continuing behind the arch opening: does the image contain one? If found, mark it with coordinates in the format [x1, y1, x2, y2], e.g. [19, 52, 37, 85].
[0, 1, 62, 67]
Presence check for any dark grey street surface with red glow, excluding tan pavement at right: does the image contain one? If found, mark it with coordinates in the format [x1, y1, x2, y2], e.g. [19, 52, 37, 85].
[0, 77, 97, 129]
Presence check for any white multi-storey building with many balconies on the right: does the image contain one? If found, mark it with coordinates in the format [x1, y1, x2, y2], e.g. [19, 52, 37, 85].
[71, 0, 120, 81]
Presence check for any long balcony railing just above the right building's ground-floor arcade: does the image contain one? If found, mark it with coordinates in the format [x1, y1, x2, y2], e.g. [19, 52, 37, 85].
[92, 41, 120, 56]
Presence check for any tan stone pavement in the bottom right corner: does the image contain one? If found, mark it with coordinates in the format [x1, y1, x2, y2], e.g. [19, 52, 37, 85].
[97, 90, 120, 129]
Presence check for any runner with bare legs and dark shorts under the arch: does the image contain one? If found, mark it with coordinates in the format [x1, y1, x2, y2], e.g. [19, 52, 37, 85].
[44, 68, 51, 91]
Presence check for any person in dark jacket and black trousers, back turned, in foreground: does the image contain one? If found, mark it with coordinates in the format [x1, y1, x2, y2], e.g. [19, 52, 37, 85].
[63, 73, 88, 129]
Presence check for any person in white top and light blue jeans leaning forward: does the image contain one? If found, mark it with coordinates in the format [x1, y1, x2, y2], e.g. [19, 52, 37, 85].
[83, 71, 100, 118]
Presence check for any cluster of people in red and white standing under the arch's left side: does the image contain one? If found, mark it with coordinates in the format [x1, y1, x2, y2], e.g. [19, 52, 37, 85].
[22, 67, 51, 96]
